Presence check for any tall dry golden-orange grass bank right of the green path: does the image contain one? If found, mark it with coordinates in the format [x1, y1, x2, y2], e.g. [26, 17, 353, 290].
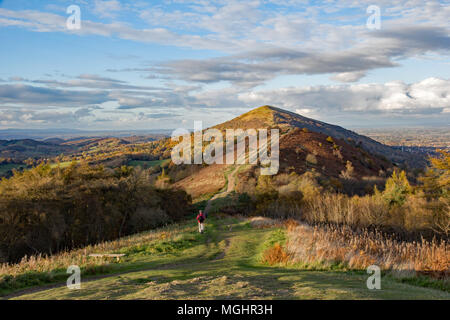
[286, 224, 450, 278]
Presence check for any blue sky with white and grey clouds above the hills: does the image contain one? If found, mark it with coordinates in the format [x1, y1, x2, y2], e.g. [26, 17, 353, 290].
[0, 0, 450, 130]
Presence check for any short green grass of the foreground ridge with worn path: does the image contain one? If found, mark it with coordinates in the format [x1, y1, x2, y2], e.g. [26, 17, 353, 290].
[4, 217, 450, 299]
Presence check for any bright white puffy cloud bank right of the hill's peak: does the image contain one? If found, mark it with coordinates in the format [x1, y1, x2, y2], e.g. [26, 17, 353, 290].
[239, 78, 450, 117]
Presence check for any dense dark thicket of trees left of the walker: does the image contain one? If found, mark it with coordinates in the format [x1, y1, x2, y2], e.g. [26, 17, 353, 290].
[0, 163, 191, 262]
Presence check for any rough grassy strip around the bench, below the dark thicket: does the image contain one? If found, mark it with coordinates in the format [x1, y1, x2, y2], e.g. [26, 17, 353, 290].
[0, 224, 204, 294]
